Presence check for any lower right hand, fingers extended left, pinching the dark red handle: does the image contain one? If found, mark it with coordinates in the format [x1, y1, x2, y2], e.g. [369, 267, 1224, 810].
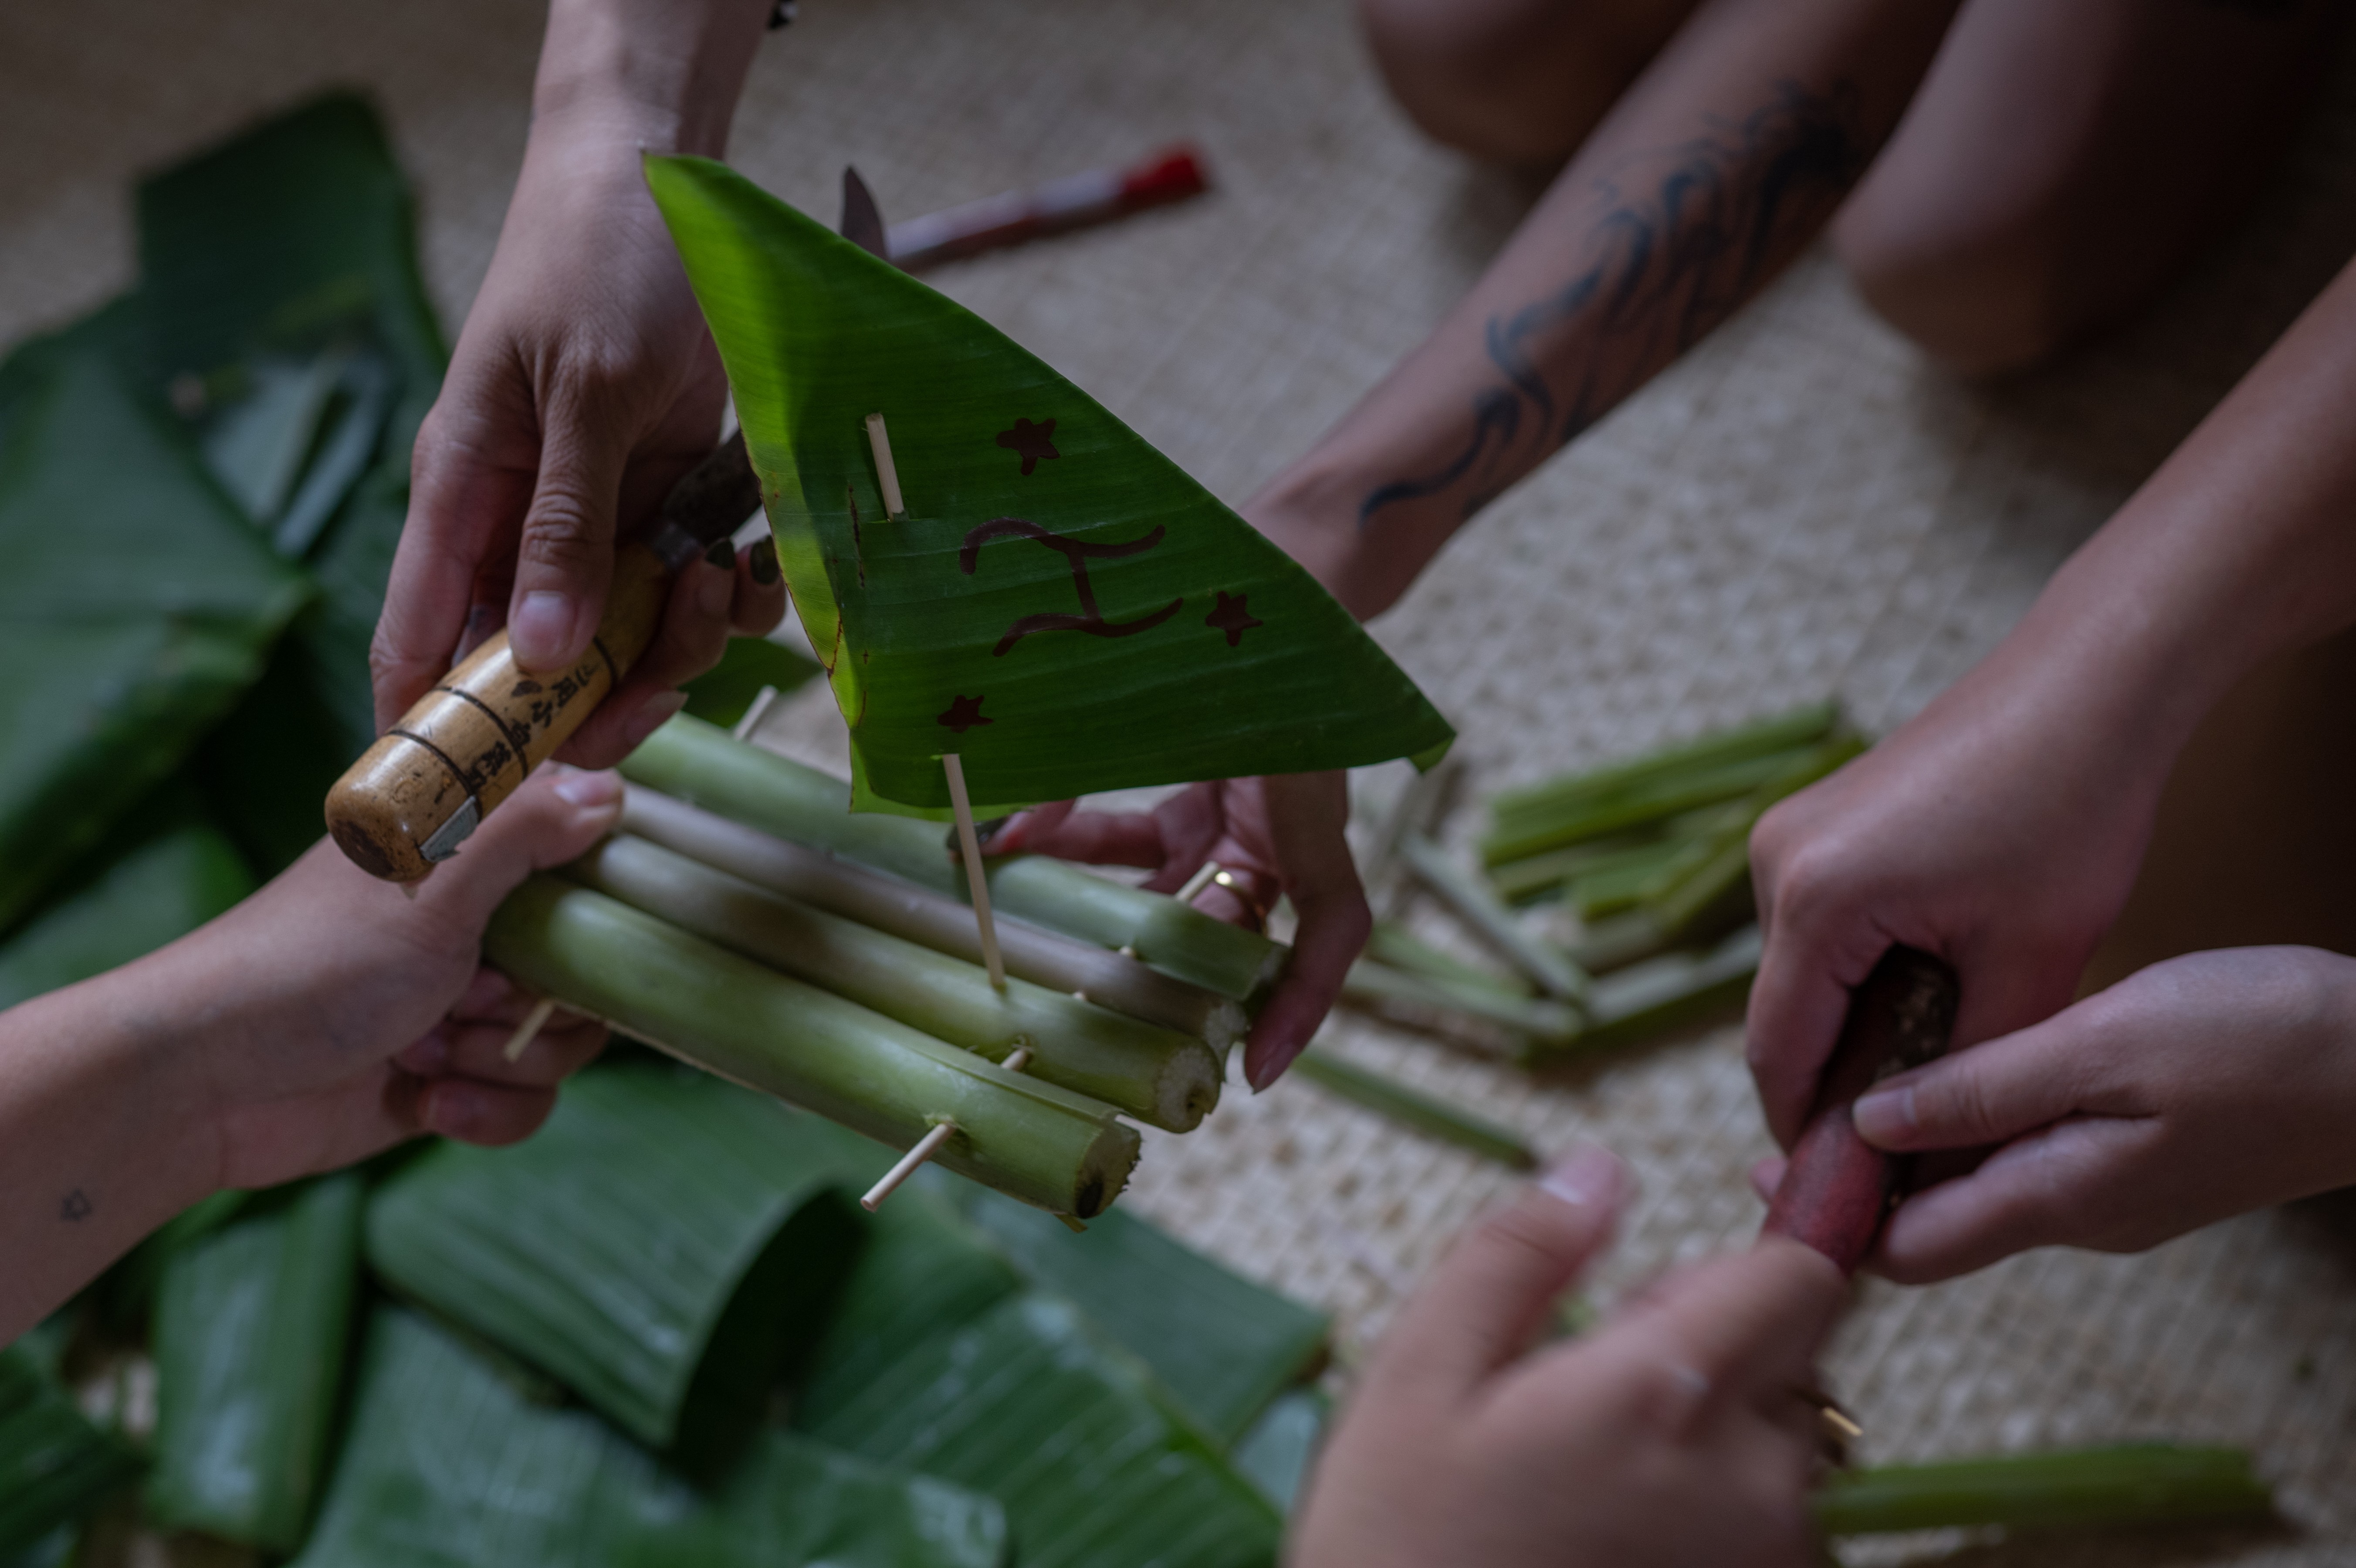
[1809, 946, 2356, 1283]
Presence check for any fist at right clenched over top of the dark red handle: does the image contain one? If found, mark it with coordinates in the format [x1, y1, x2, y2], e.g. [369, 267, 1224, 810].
[1750, 647, 2179, 1149]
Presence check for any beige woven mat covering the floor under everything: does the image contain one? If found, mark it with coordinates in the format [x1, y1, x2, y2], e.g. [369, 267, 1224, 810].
[0, 0, 2356, 1568]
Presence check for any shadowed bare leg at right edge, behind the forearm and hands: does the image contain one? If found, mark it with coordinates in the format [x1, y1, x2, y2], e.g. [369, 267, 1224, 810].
[2080, 631, 2356, 991]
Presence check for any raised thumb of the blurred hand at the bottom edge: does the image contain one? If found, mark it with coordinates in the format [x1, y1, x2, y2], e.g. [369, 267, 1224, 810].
[1369, 1144, 1628, 1399]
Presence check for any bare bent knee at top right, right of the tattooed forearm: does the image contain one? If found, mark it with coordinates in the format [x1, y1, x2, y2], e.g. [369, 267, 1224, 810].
[1833, 0, 2344, 374]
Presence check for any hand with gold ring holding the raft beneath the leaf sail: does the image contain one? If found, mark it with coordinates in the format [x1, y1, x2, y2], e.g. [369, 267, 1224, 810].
[989, 772, 1374, 1090]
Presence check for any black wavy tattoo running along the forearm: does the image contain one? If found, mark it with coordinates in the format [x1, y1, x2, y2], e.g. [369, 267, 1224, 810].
[1357, 82, 1866, 527]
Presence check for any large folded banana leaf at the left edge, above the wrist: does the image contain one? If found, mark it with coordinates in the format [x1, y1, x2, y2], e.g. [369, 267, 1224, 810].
[0, 306, 311, 928]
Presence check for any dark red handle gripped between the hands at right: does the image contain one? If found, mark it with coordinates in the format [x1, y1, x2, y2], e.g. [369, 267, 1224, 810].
[1762, 946, 1960, 1274]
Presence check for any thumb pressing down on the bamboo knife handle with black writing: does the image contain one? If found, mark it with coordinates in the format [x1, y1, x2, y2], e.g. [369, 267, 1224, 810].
[507, 386, 634, 673]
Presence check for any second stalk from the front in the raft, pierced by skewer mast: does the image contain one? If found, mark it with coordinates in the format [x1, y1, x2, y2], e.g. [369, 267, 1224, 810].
[565, 836, 1220, 1132]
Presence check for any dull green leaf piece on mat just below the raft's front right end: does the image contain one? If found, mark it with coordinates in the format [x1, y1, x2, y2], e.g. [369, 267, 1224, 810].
[959, 1186, 1331, 1443]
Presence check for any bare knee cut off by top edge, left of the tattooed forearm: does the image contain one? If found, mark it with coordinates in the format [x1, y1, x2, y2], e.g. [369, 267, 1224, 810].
[1357, 0, 1699, 165]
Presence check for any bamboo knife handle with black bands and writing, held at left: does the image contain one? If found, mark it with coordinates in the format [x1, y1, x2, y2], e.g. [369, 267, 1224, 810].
[328, 433, 761, 883]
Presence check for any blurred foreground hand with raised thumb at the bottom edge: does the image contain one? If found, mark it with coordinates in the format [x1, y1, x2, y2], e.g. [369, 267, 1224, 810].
[1289, 1149, 1845, 1568]
